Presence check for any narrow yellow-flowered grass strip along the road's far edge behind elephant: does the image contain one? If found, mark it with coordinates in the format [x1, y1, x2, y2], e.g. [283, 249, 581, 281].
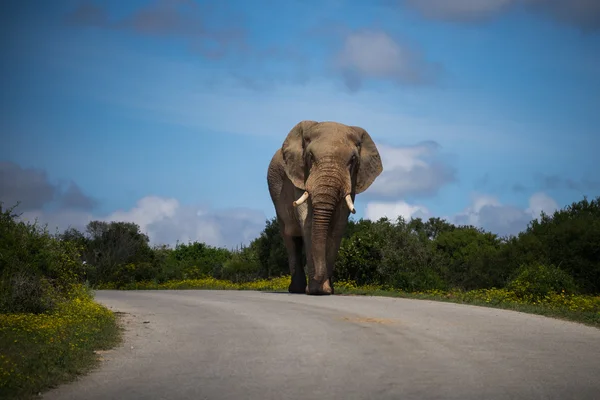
[99, 276, 600, 328]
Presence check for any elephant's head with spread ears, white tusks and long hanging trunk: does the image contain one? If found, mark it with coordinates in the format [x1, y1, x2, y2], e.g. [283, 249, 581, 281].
[281, 121, 383, 292]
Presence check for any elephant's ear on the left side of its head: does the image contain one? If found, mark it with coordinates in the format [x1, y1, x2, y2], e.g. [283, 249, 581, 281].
[281, 120, 317, 190]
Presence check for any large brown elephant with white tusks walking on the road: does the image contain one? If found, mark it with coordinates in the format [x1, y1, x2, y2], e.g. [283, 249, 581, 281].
[267, 120, 383, 295]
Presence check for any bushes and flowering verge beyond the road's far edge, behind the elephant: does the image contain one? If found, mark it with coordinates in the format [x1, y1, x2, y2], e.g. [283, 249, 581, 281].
[51, 197, 600, 326]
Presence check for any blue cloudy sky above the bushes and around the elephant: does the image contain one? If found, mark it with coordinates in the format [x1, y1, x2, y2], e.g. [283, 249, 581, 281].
[0, 0, 600, 246]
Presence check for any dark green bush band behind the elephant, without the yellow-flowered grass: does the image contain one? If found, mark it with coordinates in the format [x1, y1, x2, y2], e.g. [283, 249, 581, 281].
[5, 198, 600, 302]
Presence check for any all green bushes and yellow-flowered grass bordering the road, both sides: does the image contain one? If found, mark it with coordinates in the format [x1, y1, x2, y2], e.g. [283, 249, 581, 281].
[0, 197, 600, 398]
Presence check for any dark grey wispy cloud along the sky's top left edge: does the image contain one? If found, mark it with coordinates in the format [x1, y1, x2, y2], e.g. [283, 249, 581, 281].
[65, 0, 247, 59]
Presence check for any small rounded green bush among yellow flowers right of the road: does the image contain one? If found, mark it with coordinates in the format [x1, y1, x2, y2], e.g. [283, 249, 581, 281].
[507, 264, 577, 301]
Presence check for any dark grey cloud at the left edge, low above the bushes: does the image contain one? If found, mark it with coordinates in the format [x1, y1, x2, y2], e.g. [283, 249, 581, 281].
[0, 161, 96, 211]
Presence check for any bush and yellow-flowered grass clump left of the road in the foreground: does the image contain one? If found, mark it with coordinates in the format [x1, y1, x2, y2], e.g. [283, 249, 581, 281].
[0, 205, 120, 399]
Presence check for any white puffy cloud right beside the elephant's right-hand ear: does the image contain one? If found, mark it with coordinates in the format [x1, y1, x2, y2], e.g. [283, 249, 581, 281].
[368, 141, 456, 198]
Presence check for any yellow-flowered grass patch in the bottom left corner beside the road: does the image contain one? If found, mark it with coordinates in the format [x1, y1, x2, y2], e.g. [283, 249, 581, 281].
[0, 291, 121, 399]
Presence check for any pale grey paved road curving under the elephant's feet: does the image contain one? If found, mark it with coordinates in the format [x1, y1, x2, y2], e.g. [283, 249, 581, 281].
[44, 291, 600, 400]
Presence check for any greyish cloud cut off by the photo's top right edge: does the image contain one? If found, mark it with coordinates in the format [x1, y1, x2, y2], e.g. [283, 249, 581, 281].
[393, 0, 600, 30]
